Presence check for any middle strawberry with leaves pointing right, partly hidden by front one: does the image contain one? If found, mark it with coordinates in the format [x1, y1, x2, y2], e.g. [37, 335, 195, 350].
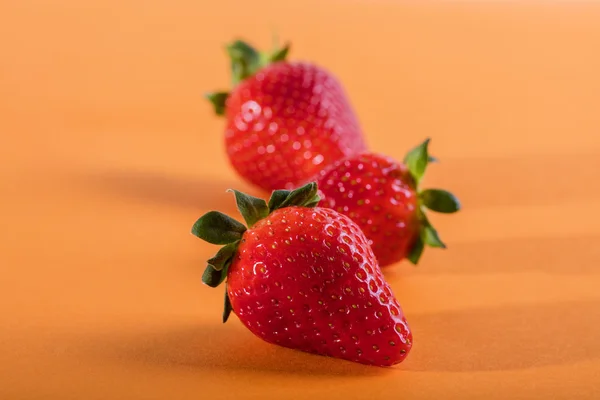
[317, 139, 460, 267]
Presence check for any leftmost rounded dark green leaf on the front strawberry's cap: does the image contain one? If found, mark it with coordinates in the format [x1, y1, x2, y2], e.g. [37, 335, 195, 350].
[192, 211, 246, 244]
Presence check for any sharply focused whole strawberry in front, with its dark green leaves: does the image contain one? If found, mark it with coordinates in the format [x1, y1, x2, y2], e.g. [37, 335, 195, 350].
[192, 183, 412, 365]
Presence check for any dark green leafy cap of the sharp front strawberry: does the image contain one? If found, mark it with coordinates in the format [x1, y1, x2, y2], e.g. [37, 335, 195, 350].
[192, 182, 320, 322]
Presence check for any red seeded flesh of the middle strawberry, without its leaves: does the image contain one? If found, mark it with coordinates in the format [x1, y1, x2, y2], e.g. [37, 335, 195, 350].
[318, 153, 420, 266]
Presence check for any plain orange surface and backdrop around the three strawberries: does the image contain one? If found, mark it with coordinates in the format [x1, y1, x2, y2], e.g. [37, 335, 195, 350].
[0, 0, 600, 400]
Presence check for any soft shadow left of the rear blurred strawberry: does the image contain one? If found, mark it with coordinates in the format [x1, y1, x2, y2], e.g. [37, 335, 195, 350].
[79, 170, 267, 212]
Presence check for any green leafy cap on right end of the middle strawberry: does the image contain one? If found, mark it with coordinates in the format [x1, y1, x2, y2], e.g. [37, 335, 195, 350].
[404, 139, 460, 265]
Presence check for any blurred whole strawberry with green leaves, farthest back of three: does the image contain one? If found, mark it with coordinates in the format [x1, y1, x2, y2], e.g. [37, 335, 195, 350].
[207, 41, 365, 191]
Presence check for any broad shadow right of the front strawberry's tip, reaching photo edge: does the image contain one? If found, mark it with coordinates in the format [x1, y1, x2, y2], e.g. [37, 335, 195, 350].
[405, 302, 600, 372]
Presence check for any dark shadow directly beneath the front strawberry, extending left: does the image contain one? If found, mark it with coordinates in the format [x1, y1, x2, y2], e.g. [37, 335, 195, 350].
[99, 325, 394, 376]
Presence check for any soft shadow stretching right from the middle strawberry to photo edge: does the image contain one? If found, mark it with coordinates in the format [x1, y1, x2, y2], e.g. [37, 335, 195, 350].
[420, 235, 600, 275]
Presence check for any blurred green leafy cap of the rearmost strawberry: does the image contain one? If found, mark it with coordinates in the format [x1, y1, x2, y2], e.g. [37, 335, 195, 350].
[204, 40, 290, 115]
